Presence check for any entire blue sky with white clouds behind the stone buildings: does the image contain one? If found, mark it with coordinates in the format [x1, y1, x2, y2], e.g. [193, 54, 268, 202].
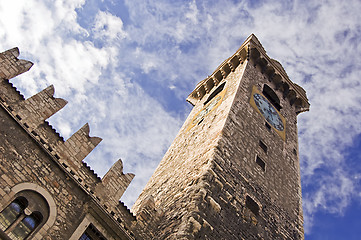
[0, 0, 361, 240]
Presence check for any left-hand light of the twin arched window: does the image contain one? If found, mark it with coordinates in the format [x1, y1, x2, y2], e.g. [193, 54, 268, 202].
[0, 197, 28, 231]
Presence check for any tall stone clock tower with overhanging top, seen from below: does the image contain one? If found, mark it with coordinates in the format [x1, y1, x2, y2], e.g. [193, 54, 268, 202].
[133, 35, 309, 240]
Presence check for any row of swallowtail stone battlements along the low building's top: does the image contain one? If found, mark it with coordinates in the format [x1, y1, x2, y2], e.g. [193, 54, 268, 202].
[0, 48, 135, 231]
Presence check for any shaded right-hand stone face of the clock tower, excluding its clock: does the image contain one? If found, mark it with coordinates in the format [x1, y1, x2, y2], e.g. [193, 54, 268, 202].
[193, 59, 303, 239]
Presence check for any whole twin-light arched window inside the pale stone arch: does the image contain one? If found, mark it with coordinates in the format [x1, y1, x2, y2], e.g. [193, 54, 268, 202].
[0, 190, 49, 240]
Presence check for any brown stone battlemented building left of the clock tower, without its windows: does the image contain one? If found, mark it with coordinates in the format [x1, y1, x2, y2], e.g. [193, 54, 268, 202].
[0, 48, 139, 240]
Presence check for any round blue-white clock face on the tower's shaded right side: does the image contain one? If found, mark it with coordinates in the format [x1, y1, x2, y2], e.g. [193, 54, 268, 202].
[253, 93, 285, 132]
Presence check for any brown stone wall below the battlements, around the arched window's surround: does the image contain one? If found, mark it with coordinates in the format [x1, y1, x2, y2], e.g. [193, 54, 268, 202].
[0, 108, 87, 239]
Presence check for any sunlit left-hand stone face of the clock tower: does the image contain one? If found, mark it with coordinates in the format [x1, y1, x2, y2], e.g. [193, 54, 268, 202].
[133, 59, 248, 239]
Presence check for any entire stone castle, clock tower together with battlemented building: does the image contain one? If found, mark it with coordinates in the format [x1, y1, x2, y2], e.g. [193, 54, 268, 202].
[0, 35, 309, 240]
